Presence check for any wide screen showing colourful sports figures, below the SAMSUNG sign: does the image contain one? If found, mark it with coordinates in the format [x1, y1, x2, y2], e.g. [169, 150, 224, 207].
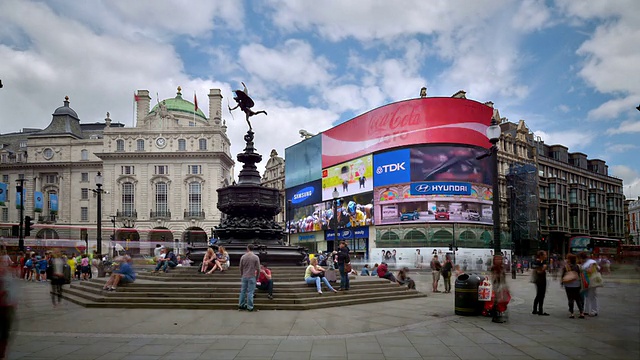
[287, 192, 374, 234]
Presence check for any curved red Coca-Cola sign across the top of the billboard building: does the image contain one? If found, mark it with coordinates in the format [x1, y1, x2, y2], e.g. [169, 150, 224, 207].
[322, 98, 493, 168]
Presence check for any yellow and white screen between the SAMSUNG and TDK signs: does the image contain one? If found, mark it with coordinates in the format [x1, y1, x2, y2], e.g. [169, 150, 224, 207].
[322, 155, 373, 200]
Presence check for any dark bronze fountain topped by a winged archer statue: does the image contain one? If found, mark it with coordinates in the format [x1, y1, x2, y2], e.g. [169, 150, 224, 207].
[205, 83, 306, 266]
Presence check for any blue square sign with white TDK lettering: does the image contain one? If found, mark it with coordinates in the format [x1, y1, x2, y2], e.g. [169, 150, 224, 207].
[373, 149, 411, 186]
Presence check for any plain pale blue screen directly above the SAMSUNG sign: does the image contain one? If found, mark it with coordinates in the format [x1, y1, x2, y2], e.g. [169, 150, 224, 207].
[284, 135, 322, 188]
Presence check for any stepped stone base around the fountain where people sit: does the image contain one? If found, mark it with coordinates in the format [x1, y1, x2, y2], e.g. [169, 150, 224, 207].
[63, 267, 426, 310]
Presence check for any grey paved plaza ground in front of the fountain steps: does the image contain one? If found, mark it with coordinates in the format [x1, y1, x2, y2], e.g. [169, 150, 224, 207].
[9, 273, 640, 360]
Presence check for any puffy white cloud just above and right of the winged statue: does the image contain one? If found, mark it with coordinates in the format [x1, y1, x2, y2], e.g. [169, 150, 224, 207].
[239, 39, 332, 88]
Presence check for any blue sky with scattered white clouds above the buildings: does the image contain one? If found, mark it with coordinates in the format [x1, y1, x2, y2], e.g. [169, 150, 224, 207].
[0, 0, 640, 198]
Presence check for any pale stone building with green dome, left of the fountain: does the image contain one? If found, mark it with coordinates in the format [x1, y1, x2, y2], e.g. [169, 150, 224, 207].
[0, 88, 234, 254]
